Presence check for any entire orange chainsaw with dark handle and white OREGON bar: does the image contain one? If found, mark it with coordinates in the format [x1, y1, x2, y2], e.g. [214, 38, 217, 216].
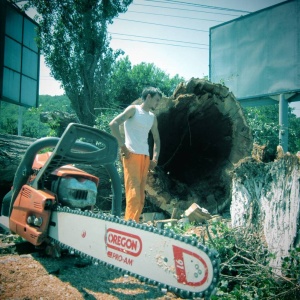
[0, 123, 220, 299]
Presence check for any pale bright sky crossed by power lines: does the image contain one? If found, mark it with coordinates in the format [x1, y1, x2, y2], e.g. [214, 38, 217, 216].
[39, 0, 300, 113]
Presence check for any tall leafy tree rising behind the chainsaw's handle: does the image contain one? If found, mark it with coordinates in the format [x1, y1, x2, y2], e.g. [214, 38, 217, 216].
[24, 0, 132, 125]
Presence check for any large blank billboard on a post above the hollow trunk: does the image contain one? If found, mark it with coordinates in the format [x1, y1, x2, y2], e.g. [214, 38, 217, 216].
[209, 0, 300, 100]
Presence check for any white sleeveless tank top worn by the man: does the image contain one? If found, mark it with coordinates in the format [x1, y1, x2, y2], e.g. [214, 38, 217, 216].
[124, 105, 154, 156]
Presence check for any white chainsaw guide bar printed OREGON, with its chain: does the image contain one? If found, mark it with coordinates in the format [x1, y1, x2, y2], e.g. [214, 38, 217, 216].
[48, 206, 220, 299]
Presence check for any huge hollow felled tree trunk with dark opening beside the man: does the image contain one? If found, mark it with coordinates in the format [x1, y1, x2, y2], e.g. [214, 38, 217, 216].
[146, 79, 252, 215]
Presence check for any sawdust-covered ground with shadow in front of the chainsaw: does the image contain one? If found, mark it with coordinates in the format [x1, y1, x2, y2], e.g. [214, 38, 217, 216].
[0, 231, 182, 300]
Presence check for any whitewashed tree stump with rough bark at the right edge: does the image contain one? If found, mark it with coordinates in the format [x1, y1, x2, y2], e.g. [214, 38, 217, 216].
[231, 154, 300, 274]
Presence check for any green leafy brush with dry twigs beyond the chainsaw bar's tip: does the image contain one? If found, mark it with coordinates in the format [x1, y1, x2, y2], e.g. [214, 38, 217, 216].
[207, 222, 300, 300]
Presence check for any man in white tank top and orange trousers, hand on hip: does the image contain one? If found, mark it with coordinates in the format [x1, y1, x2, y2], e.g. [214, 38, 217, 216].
[109, 87, 162, 222]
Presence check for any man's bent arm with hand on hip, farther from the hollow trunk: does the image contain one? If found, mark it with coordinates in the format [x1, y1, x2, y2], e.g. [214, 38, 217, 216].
[109, 105, 135, 156]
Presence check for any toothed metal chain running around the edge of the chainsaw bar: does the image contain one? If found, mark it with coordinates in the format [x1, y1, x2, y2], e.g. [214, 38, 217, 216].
[50, 206, 220, 299]
